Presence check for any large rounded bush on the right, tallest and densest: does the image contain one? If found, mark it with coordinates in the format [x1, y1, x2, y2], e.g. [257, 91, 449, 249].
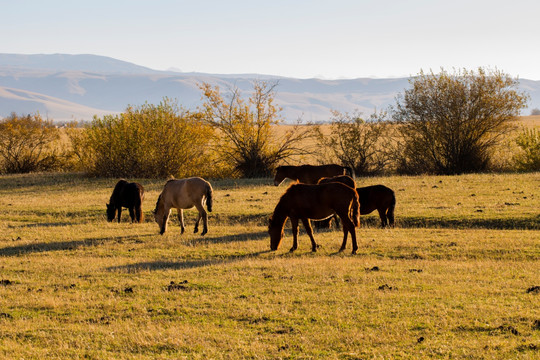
[392, 68, 528, 174]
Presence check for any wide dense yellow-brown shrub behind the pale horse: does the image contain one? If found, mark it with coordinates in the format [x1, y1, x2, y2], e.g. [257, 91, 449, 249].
[71, 98, 214, 177]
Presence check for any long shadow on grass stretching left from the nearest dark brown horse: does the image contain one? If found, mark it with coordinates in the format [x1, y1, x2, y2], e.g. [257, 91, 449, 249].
[106, 250, 271, 273]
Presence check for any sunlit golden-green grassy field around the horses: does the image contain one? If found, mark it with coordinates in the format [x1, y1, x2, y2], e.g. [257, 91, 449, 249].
[0, 173, 540, 359]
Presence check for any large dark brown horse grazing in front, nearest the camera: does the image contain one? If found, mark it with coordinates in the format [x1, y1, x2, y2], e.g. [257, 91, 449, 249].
[268, 183, 360, 254]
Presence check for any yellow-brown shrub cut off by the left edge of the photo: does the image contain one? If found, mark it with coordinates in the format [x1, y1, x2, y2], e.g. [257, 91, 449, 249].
[0, 113, 65, 173]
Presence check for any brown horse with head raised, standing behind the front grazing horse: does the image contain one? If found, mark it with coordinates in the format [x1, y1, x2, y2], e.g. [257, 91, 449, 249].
[274, 164, 352, 186]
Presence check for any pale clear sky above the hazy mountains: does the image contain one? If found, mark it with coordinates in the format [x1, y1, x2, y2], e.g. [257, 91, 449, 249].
[0, 0, 540, 80]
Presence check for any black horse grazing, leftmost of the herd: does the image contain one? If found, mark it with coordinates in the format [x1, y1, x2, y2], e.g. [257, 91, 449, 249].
[107, 179, 144, 223]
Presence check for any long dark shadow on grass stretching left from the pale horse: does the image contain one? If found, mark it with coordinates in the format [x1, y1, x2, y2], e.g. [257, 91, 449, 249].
[0, 235, 155, 256]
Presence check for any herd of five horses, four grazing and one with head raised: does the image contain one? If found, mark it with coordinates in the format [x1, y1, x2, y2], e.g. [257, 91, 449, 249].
[107, 164, 396, 254]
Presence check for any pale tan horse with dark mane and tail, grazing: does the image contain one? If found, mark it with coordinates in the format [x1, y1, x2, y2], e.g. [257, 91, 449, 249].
[153, 177, 213, 235]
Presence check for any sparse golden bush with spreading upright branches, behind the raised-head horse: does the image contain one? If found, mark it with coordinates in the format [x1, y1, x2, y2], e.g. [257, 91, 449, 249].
[200, 81, 315, 178]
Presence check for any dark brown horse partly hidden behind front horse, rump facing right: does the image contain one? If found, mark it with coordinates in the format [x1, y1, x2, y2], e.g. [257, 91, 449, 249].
[319, 175, 396, 228]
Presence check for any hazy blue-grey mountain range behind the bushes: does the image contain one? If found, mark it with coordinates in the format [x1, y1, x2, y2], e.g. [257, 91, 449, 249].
[0, 54, 540, 122]
